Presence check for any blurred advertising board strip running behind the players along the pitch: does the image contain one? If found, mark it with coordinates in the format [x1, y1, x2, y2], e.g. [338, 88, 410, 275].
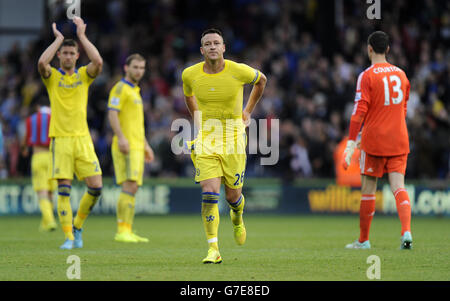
[0, 181, 450, 216]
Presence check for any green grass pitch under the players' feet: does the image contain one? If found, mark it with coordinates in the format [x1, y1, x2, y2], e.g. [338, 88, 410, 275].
[0, 214, 450, 281]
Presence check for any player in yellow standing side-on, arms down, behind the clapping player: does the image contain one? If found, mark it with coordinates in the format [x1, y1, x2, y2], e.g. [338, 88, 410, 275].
[108, 54, 154, 242]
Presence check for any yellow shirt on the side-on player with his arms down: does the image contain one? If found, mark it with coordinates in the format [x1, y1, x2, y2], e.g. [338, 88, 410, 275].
[108, 79, 145, 150]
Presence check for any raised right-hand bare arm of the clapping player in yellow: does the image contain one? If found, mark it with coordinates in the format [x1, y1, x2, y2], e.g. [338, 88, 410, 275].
[73, 17, 103, 77]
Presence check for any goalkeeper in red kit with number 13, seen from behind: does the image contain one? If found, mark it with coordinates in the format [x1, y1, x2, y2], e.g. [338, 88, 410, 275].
[343, 31, 412, 249]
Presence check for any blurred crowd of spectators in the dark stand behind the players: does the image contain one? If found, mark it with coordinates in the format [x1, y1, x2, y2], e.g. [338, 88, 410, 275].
[0, 0, 450, 180]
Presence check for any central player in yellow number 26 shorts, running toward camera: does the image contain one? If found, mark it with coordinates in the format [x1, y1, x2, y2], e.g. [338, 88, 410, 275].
[182, 29, 267, 263]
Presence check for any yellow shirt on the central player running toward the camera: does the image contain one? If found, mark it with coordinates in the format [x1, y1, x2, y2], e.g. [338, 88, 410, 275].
[182, 60, 261, 148]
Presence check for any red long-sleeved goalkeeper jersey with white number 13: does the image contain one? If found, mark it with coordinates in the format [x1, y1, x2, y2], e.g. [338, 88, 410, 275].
[352, 63, 410, 156]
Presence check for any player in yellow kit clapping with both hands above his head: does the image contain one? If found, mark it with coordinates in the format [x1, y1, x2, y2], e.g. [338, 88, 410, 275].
[38, 17, 103, 249]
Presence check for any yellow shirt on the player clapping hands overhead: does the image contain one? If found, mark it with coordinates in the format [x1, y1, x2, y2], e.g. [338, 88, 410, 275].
[41, 66, 95, 137]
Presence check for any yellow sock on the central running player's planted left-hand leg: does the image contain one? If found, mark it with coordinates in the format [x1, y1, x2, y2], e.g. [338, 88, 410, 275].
[202, 192, 220, 250]
